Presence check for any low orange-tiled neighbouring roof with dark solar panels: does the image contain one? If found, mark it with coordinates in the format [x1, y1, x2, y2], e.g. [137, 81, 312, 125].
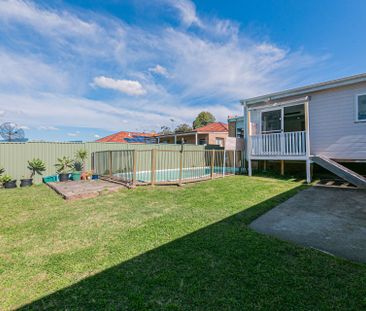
[96, 131, 157, 144]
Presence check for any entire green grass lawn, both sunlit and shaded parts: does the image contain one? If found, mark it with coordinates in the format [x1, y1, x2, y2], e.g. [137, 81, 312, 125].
[0, 176, 366, 310]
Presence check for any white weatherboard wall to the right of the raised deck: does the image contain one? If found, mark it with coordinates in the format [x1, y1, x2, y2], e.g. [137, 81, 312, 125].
[309, 83, 366, 160]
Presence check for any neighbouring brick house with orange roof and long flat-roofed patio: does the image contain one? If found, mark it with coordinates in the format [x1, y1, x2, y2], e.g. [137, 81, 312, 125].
[157, 122, 228, 147]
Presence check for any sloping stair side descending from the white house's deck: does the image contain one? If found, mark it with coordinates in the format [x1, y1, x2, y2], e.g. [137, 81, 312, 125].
[311, 155, 366, 189]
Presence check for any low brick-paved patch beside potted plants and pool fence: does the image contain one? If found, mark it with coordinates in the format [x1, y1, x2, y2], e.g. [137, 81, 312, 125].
[47, 180, 125, 200]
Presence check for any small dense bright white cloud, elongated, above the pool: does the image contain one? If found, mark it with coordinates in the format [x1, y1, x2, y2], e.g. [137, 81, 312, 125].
[94, 76, 146, 96]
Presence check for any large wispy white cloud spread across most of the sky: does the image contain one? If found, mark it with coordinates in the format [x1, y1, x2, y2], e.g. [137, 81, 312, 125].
[0, 0, 326, 138]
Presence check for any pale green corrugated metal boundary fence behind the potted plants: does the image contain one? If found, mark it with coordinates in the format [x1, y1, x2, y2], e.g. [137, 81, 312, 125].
[0, 142, 213, 183]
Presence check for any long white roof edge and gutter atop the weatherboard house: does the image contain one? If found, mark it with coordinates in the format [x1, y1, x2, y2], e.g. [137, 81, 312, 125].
[240, 73, 366, 105]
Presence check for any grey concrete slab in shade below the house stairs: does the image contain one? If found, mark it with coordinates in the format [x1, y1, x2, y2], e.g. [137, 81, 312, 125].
[250, 187, 366, 263]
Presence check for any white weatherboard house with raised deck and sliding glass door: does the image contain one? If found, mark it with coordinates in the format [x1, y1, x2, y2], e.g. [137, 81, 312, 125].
[241, 74, 366, 187]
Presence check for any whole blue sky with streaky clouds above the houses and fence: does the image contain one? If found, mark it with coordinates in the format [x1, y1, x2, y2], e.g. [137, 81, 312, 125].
[0, 0, 366, 141]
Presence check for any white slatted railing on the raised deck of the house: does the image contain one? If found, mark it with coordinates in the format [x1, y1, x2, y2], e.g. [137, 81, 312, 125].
[250, 131, 306, 156]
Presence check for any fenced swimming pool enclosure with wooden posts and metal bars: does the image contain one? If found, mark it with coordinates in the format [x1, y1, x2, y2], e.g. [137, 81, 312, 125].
[93, 148, 242, 185]
